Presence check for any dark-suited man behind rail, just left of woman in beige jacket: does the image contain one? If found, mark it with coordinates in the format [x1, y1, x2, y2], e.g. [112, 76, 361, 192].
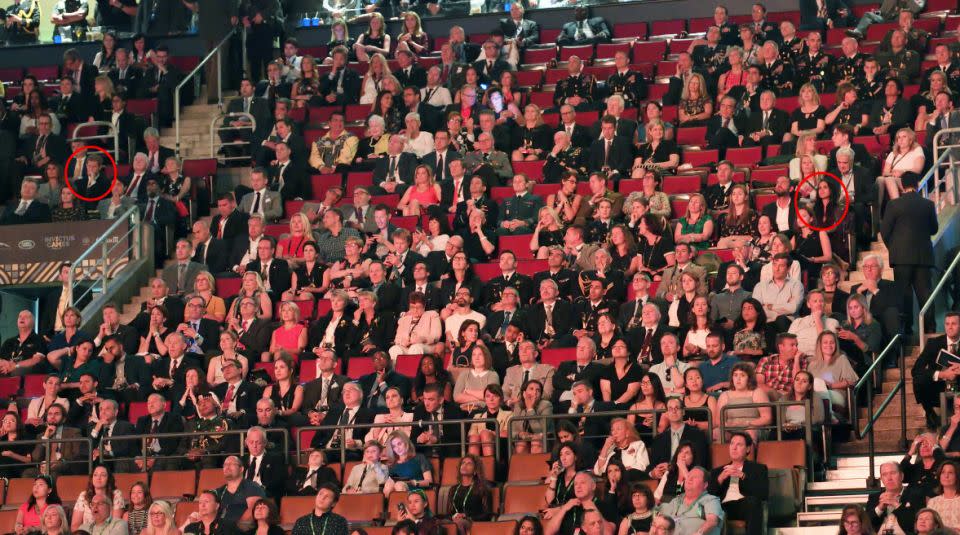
[410, 383, 467, 457]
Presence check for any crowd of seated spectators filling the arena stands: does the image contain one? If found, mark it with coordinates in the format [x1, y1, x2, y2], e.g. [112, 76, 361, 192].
[0, 2, 960, 535]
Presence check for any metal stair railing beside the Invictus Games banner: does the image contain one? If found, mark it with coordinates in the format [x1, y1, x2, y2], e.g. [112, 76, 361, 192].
[67, 206, 142, 306]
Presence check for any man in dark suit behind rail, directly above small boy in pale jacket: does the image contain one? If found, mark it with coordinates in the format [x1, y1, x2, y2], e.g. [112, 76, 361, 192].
[310, 382, 376, 462]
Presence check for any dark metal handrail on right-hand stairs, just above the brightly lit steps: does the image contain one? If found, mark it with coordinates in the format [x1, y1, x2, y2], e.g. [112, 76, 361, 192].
[850, 333, 907, 487]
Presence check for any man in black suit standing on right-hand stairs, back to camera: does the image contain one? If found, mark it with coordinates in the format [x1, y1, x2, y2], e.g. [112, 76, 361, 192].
[880, 172, 939, 332]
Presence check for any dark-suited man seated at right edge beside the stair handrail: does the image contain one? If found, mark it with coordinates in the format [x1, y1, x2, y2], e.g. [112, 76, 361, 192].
[911, 311, 960, 428]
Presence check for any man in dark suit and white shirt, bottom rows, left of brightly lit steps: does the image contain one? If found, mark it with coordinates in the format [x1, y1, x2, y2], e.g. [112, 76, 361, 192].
[708, 431, 770, 535]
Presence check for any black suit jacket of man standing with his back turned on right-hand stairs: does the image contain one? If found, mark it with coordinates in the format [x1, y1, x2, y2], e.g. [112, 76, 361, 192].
[880, 191, 939, 266]
